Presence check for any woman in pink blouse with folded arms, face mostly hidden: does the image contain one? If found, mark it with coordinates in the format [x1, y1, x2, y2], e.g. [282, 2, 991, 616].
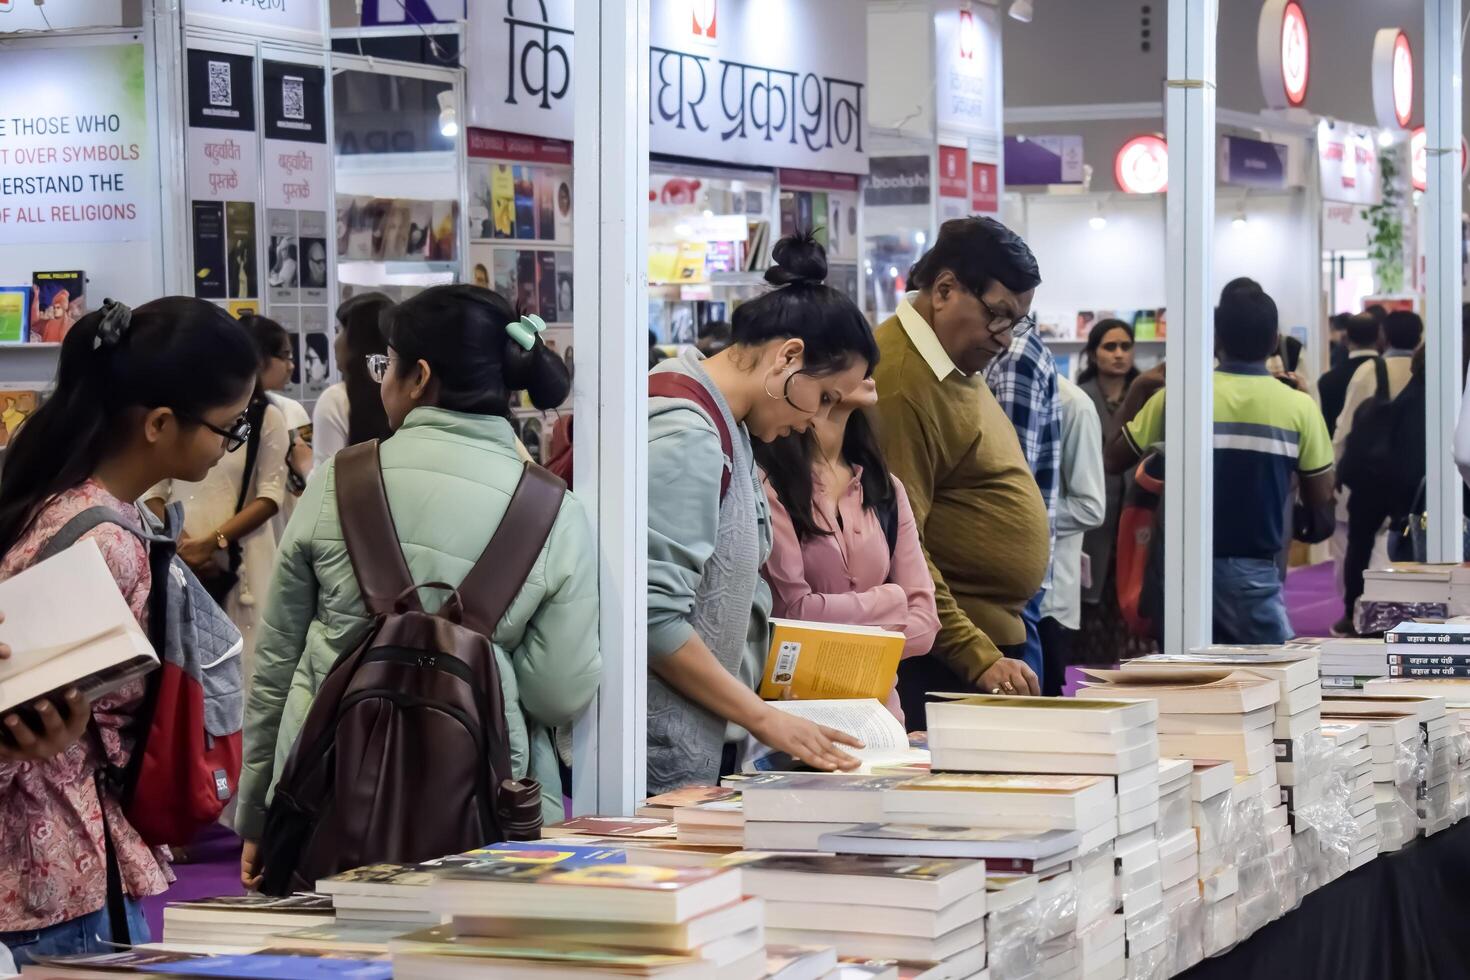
[757, 378, 939, 721]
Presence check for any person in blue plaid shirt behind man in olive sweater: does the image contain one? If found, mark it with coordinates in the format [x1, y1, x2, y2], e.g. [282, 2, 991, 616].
[985, 320, 1061, 679]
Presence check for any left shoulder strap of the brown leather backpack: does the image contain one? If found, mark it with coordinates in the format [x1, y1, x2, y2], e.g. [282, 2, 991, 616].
[334, 439, 420, 616]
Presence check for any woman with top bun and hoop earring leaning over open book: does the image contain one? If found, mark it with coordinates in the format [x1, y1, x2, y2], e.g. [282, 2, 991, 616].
[648, 235, 878, 795]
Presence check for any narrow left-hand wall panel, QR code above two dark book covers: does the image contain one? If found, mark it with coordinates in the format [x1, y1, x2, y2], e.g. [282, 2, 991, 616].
[184, 48, 260, 300]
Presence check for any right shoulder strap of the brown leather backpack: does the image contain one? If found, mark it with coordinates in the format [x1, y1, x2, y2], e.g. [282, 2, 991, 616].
[459, 463, 566, 638]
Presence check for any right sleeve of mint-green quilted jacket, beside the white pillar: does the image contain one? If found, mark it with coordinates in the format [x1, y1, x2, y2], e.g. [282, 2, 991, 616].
[513, 494, 603, 727]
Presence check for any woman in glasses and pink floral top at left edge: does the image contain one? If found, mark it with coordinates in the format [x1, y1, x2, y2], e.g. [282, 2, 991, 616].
[0, 297, 259, 965]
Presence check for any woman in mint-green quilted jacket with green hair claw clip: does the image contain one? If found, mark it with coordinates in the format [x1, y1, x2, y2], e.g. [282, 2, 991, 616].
[235, 285, 601, 884]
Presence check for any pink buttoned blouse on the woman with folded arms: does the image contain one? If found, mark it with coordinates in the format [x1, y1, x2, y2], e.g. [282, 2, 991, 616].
[766, 467, 939, 721]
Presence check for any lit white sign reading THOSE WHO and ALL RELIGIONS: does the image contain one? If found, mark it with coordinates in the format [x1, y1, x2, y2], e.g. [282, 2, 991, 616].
[0, 44, 157, 245]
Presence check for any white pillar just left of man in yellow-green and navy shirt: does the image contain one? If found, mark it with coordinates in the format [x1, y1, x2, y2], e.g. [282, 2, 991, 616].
[1164, 0, 1219, 654]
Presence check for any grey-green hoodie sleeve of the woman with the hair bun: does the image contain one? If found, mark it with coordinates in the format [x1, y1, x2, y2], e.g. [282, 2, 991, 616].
[648, 398, 725, 657]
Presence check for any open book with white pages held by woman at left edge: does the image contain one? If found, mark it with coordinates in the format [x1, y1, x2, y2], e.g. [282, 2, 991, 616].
[0, 539, 159, 711]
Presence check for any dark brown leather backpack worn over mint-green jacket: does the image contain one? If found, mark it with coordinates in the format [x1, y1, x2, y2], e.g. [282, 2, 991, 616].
[260, 441, 566, 895]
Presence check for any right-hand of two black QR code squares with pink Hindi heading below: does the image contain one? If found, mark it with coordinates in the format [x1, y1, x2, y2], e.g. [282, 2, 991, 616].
[260, 60, 332, 212]
